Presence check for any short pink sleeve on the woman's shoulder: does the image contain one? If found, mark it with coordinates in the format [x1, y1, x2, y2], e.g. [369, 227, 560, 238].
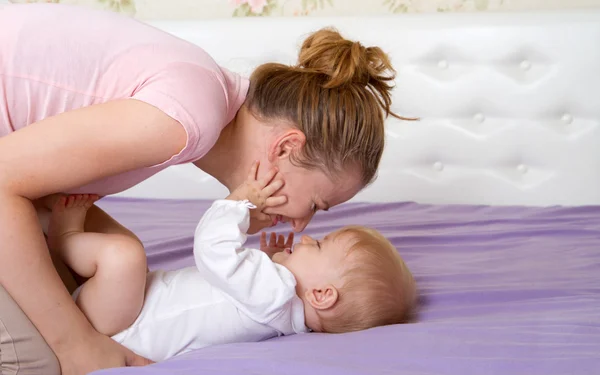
[132, 63, 228, 165]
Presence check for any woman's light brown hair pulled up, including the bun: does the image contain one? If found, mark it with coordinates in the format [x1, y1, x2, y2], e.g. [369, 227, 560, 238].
[246, 29, 406, 186]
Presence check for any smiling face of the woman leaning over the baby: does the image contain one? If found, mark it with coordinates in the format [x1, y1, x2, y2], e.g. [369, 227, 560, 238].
[264, 159, 363, 232]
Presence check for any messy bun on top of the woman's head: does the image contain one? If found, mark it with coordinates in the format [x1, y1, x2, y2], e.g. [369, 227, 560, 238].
[298, 29, 395, 88]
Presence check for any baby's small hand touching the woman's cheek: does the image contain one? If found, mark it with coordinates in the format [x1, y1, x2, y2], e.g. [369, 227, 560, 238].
[226, 161, 287, 221]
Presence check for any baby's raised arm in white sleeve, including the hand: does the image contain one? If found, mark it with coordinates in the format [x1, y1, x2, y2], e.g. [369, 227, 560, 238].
[194, 163, 296, 324]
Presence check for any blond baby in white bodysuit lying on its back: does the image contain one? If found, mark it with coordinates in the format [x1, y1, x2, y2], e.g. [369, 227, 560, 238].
[48, 163, 416, 361]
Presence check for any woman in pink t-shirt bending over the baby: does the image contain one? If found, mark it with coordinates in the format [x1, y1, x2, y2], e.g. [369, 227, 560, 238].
[0, 4, 406, 375]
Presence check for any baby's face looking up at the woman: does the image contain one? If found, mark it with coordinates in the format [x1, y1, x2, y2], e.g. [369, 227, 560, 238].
[273, 232, 352, 293]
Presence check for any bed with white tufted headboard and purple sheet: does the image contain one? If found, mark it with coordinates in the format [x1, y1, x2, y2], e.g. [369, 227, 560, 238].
[94, 10, 600, 375]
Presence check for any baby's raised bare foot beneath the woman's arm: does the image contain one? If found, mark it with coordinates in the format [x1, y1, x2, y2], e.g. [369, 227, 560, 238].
[48, 194, 98, 245]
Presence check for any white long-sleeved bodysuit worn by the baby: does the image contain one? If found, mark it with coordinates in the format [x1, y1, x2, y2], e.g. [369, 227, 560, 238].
[113, 200, 308, 361]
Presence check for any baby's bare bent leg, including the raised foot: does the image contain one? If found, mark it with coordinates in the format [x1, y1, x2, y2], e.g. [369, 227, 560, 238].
[48, 195, 147, 335]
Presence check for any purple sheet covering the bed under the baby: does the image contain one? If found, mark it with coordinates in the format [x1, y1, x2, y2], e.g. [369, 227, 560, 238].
[94, 198, 600, 375]
